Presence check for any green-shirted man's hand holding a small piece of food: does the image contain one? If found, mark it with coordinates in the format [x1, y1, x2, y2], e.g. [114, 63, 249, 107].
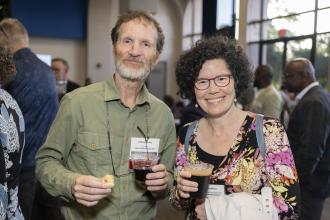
[71, 175, 111, 207]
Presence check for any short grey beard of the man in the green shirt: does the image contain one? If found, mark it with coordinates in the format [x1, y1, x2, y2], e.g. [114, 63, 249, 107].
[115, 59, 151, 82]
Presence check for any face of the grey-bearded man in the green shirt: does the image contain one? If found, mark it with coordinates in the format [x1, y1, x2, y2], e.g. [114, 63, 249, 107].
[113, 19, 159, 81]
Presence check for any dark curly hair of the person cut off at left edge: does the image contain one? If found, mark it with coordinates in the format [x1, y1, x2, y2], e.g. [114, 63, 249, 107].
[0, 43, 16, 86]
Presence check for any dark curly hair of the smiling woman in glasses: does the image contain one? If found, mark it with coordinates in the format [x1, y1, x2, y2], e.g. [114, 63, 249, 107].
[175, 35, 253, 103]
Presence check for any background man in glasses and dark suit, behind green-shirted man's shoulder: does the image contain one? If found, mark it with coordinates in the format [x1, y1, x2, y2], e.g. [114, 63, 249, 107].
[52, 58, 80, 100]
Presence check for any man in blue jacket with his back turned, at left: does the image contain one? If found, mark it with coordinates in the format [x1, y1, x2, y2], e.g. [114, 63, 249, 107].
[0, 18, 58, 219]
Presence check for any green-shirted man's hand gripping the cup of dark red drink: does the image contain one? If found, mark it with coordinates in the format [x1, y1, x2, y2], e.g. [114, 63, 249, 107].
[145, 164, 168, 191]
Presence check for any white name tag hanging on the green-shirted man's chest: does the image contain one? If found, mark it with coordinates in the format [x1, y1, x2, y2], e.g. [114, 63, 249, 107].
[130, 137, 160, 156]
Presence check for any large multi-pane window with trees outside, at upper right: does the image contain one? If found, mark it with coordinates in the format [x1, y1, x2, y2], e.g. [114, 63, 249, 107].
[247, 0, 330, 89]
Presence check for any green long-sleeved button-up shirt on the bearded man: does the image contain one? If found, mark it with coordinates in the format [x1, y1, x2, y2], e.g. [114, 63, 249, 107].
[36, 77, 175, 220]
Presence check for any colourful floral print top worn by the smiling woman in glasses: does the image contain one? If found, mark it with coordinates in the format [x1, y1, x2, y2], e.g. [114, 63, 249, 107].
[170, 112, 300, 219]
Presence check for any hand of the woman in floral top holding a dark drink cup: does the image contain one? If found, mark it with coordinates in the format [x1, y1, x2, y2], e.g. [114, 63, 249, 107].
[177, 171, 198, 199]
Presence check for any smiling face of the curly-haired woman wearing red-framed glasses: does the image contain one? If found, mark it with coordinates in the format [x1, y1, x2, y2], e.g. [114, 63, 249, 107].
[195, 59, 236, 117]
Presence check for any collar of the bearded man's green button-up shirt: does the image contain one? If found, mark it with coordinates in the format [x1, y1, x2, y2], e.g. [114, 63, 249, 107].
[104, 75, 150, 105]
